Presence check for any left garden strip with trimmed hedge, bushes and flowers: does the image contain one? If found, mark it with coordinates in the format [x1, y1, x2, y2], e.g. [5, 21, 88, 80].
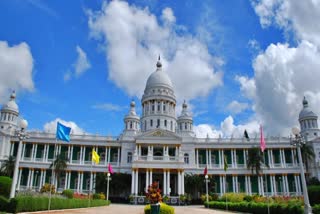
[0, 176, 110, 213]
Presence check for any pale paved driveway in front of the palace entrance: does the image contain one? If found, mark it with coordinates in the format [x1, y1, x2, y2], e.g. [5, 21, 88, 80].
[27, 204, 238, 214]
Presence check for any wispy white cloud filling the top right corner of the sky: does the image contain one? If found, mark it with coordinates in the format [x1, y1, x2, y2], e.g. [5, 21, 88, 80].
[252, 0, 320, 45]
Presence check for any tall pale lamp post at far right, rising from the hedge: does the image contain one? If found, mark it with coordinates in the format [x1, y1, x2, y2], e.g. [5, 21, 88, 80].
[291, 127, 312, 214]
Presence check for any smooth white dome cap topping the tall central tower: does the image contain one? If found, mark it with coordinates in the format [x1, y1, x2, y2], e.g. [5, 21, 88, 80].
[146, 61, 173, 89]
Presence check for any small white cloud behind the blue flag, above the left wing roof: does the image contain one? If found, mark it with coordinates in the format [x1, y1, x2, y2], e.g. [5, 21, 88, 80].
[43, 118, 87, 135]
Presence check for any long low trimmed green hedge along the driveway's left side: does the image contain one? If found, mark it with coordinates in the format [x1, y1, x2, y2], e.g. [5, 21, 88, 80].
[1, 196, 110, 213]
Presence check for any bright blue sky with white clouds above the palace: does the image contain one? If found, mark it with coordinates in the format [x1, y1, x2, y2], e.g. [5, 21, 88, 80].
[0, 0, 320, 137]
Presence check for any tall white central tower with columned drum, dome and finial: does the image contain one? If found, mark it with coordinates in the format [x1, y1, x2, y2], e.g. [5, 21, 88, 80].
[141, 56, 177, 132]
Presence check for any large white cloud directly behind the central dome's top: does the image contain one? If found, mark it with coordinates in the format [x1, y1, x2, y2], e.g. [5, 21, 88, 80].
[88, 1, 223, 99]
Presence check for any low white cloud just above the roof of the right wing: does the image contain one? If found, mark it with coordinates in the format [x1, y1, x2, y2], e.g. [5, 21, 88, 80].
[193, 116, 260, 138]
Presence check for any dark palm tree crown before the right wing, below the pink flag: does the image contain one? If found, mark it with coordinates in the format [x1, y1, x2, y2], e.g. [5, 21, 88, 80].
[247, 147, 265, 175]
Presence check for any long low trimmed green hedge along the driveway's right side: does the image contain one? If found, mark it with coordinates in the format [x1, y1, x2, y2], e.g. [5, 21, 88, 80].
[204, 201, 303, 214]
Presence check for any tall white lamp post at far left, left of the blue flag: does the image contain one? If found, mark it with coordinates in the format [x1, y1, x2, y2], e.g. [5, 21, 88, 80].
[10, 119, 28, 198]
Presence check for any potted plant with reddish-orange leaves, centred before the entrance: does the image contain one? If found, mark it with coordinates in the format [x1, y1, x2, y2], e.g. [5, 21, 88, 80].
[146, 182, 162, 214]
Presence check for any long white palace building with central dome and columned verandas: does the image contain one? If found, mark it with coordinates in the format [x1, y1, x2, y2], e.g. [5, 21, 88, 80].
[0, 61, 320, 201]
